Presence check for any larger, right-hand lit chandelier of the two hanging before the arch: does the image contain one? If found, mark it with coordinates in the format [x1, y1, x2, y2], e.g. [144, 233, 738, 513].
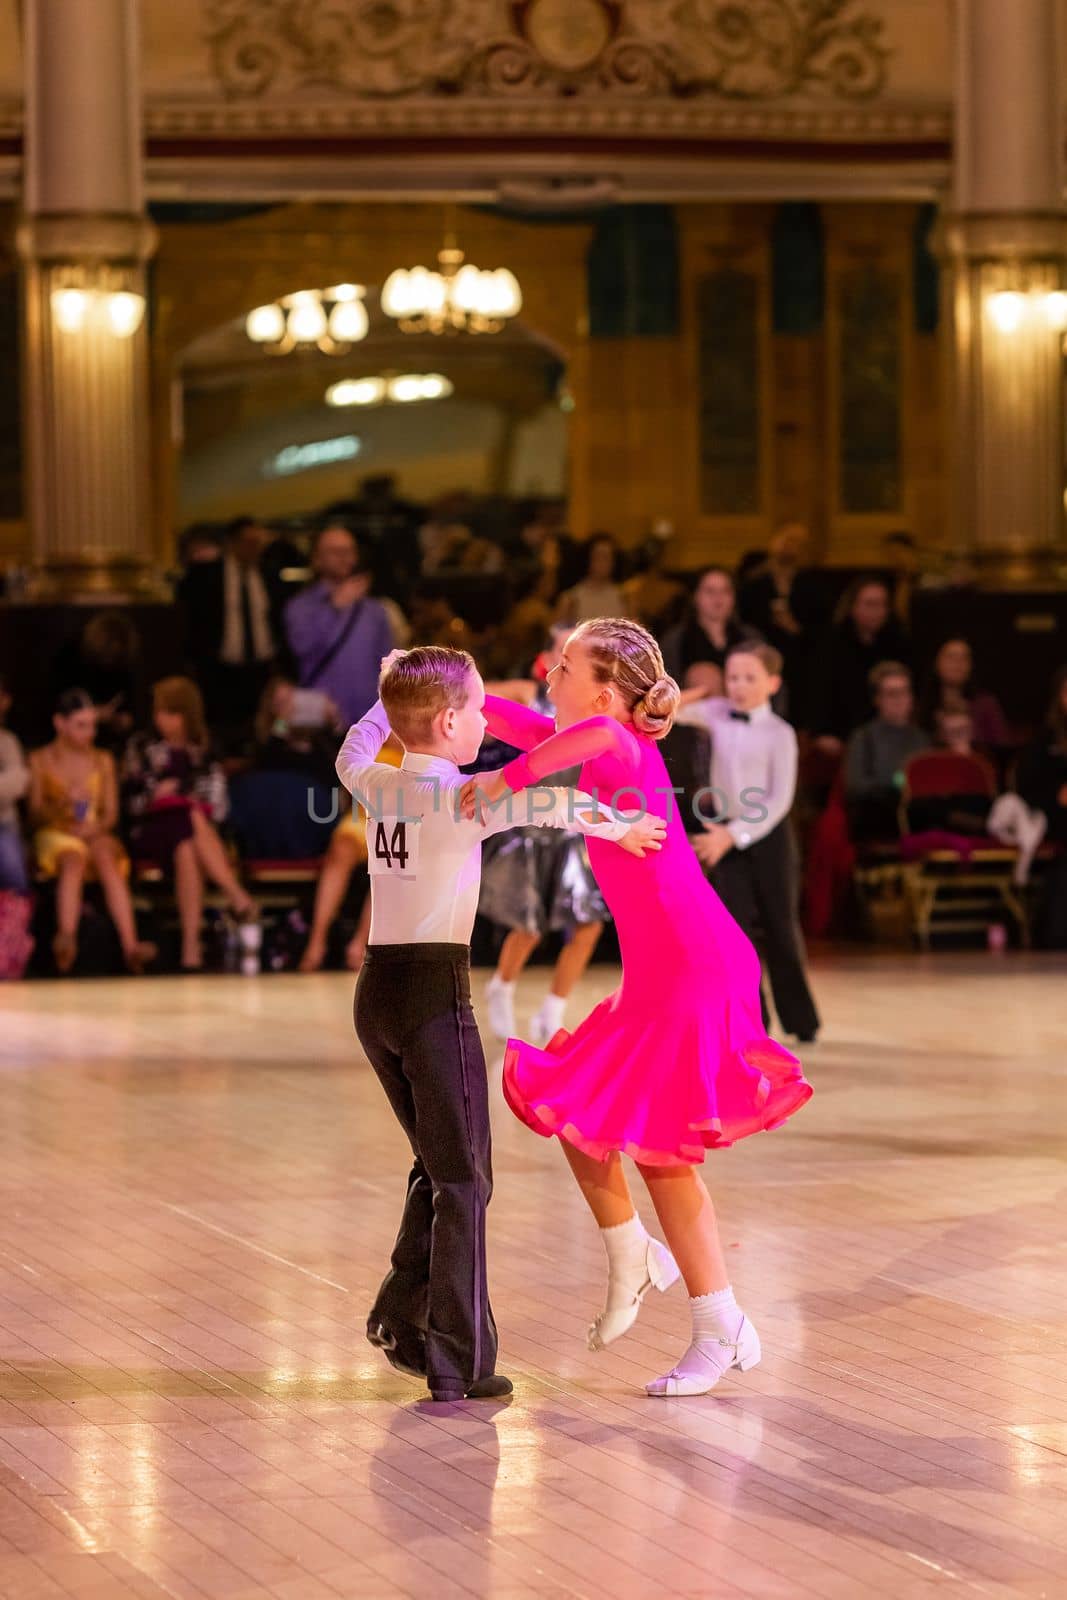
[382, 237, 523, 333]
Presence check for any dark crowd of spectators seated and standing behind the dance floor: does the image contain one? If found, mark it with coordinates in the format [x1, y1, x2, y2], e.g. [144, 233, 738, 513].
[0, 478, 1067, 976]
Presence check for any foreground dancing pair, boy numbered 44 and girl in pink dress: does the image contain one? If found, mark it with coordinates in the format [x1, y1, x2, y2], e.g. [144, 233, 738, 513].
[338, 619, 811, 1400]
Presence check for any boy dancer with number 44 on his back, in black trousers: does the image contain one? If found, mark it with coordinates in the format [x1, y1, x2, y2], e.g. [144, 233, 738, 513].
[338, 646, 665, 1400]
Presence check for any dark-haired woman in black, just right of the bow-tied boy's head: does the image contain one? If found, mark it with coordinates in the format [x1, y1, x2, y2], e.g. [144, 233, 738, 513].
[809, 578, 910, 754]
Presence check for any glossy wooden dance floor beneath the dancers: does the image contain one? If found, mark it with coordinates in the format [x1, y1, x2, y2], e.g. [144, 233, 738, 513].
[0, 955, 1067, 1600]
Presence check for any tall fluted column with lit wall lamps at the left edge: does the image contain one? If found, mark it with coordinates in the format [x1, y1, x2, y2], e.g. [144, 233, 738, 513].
[18, 0, 155, 600]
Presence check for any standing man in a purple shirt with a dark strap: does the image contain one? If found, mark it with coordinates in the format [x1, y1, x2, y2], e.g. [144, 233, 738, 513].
[285, 522, 394, 726]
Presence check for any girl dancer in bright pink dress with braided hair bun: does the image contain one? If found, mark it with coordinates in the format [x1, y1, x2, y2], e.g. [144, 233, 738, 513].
[466, 618, 811, 1395]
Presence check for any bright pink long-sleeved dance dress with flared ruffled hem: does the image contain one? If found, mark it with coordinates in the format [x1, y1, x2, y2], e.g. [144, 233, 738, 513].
[485, 696, 811, 1166]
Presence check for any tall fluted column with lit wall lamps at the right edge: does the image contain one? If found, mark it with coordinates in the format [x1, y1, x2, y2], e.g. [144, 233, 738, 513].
[942, 0, 1067, 584]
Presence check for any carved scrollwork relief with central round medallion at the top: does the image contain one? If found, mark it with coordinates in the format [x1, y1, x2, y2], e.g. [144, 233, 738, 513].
[202, 0, 889, 102]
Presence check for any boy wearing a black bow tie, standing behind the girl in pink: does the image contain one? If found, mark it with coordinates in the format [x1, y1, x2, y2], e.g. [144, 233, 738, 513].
[675, 642, 819, 1043]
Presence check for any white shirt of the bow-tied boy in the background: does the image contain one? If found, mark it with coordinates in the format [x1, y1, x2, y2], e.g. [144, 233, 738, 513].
[675, 696, 797, 850]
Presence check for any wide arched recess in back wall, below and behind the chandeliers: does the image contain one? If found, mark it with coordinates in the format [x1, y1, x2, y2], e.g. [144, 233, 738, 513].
[176, 283, 569, 525]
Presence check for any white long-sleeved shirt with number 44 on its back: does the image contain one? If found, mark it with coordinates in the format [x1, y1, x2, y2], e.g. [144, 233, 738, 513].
[338, 701, 630, 944]
